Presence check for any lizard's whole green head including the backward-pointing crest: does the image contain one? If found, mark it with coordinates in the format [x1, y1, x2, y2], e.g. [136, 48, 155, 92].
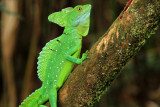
[48, 4, 91, 36]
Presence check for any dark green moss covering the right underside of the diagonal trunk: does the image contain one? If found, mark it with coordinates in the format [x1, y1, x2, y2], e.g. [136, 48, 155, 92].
[83, 0, 160, 106]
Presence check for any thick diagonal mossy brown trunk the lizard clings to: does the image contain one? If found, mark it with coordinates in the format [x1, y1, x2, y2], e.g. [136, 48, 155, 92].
[58, 0, 160, 107]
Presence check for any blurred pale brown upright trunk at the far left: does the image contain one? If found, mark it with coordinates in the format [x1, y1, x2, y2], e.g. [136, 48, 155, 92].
[1, 0, 20, 107]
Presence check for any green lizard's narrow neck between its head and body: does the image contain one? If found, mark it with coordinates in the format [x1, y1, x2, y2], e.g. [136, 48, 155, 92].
[63, 26, 82, 38]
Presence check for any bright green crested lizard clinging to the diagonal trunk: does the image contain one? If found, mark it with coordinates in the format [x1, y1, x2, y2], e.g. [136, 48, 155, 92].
[20, 4, 91, 107]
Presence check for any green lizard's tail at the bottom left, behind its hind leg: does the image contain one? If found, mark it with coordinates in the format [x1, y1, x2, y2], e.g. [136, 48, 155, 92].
[19, 87, 48, 107]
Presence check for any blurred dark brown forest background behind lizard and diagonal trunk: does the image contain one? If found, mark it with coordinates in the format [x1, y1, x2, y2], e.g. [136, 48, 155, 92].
[0, 0, 160, 107]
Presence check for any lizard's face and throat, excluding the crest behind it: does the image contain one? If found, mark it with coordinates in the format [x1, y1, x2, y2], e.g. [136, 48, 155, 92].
[68, 4, 91, 36]
